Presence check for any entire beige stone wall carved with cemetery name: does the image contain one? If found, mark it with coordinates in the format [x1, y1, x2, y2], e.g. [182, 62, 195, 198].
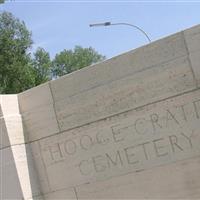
[0, 26, 200, 199]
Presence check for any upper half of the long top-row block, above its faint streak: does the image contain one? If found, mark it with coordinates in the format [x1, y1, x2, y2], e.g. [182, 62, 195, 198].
[50, 33, 187, 101]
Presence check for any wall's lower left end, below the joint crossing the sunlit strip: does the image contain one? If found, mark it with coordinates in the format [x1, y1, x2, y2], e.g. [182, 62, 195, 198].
[0, 144, 40, 199]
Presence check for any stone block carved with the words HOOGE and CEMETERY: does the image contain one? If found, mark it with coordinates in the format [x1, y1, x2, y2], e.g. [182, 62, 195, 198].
[40, 91, 200, 189]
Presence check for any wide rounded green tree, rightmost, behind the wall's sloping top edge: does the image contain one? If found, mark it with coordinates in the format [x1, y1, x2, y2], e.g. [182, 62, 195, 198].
[52, 46, 105, 77]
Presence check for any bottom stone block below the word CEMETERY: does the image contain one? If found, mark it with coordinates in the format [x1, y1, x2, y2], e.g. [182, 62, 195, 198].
[76, 157, 200, 200]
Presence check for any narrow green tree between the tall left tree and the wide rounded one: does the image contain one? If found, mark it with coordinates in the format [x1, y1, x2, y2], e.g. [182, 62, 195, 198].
[33, 47, 51, 85]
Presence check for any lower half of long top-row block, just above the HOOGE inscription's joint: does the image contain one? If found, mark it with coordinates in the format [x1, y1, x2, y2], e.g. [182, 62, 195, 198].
[55, 56, 196, 131]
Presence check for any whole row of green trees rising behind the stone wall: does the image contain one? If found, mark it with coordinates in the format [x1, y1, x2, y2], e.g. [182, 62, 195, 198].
[0, 12, 105, 94]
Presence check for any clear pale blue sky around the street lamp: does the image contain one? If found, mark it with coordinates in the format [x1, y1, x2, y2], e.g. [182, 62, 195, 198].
[0, 0, 200, 58]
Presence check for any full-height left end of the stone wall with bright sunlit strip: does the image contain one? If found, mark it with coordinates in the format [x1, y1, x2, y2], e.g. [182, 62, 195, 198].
[0, 95, 40, 199]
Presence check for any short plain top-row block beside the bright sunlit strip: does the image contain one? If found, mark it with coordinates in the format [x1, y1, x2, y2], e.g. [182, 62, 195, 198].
[18, 83, 59, 141]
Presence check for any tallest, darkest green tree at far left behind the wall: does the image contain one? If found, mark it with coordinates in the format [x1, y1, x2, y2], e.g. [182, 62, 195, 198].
[0, 12, 35, 93]
